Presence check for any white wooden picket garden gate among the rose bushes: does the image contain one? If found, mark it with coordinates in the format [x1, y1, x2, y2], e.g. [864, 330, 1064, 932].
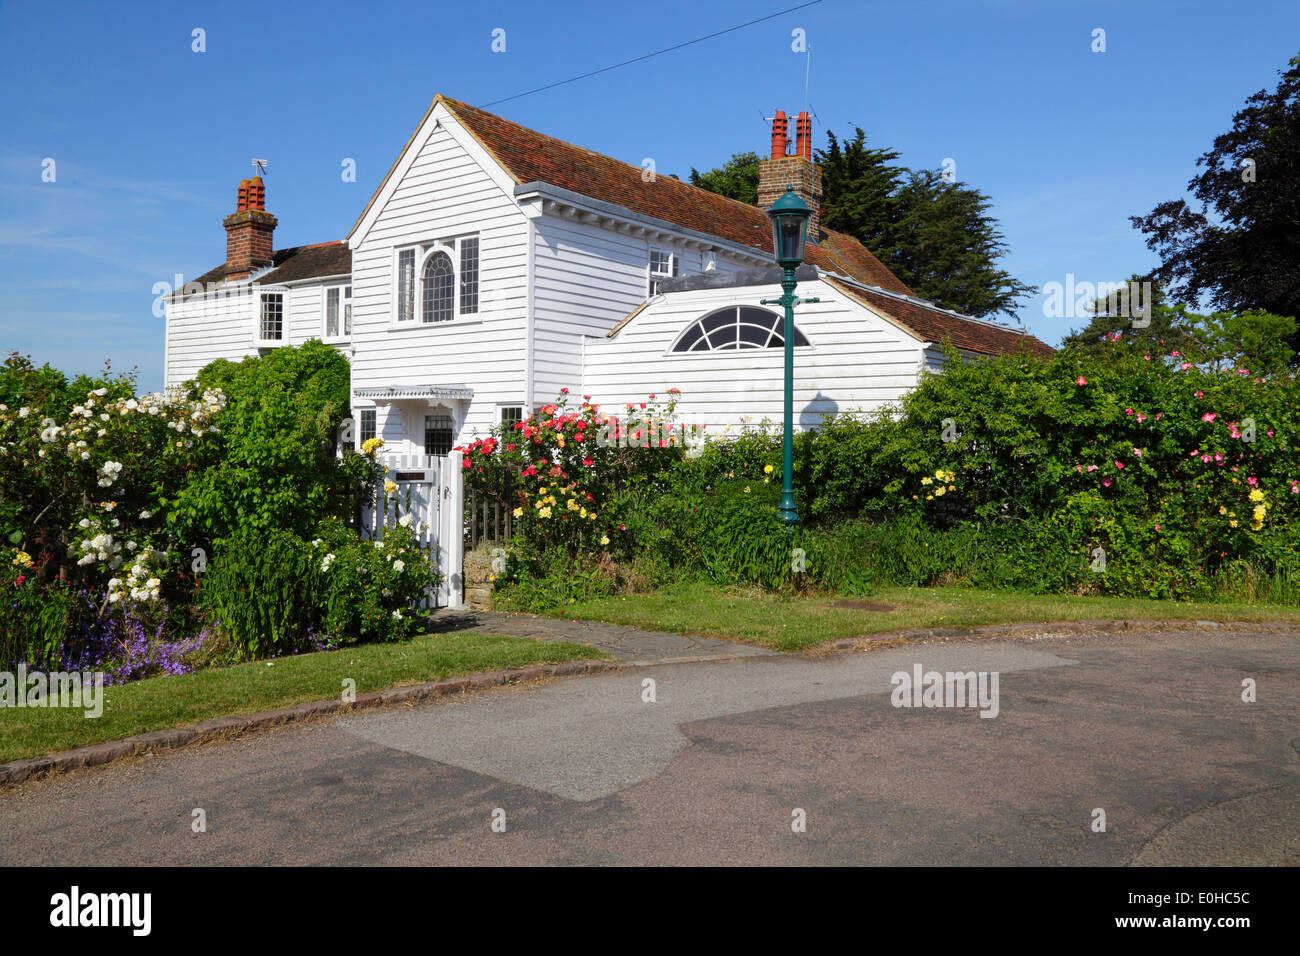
[361, 451, 464, 610]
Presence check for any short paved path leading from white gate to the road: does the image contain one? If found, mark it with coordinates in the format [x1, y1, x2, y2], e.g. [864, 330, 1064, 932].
[429, 609, 777, 663]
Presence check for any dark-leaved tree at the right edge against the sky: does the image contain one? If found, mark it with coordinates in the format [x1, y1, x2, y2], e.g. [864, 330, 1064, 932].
[1130, 56, 1300, 349]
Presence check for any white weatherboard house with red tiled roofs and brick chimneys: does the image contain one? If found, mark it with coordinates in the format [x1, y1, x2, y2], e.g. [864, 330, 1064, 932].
[165, 95, 1050, 457]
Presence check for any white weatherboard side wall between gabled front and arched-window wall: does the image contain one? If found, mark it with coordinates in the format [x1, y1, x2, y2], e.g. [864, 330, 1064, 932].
[533, 215, 750, 403]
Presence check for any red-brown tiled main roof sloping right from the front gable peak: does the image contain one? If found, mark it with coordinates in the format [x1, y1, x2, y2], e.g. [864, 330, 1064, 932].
[434, 94, 911, 294]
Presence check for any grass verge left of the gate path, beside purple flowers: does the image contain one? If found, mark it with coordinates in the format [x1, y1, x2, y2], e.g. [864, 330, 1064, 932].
[0, 633, 610, 762]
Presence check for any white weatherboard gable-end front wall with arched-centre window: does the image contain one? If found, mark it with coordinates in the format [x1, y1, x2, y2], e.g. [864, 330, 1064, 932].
[352, 107, 528, 453]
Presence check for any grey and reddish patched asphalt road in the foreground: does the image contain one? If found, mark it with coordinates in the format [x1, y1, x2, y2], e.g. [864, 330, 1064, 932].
[0, 627, 1300, 865]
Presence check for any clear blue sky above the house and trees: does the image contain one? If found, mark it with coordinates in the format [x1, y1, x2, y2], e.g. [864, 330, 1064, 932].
[0, 0, 1300, 390]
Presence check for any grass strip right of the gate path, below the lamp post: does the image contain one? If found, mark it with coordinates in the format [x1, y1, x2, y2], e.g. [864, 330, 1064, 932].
[554, 584, 1300, 650]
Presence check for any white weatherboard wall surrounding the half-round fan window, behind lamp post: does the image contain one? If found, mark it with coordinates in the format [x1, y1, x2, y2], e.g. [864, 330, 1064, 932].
[582, 282, 920, 433]
